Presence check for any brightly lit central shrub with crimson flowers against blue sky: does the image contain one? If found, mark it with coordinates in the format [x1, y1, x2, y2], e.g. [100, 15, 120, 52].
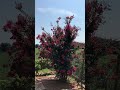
[37, 16, 79, 81]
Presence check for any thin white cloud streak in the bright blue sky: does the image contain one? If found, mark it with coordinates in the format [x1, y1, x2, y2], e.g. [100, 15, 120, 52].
[37, 8, 77, 16]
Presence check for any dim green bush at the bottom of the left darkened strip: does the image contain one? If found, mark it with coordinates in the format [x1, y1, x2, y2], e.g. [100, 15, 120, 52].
[0, 76, 35, 90]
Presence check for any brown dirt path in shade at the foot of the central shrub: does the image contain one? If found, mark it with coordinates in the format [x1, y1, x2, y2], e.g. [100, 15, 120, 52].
[35, 75, 81, 90]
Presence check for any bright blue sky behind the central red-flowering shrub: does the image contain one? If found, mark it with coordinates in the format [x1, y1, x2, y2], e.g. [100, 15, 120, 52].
[35, 0, 85, 43]
